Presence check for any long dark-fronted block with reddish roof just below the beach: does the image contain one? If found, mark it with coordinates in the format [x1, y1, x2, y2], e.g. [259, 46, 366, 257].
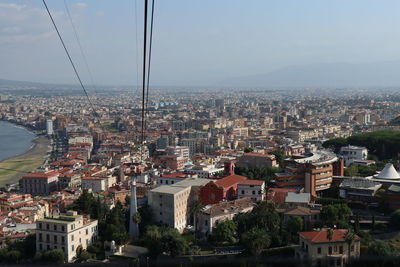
[19, 171, 59, 195]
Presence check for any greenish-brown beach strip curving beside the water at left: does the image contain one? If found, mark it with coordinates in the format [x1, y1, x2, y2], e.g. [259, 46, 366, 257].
[0, 136, 50, 187]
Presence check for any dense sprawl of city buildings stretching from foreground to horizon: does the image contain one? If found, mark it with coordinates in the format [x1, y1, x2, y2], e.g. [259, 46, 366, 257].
[0, 88, 400, 266]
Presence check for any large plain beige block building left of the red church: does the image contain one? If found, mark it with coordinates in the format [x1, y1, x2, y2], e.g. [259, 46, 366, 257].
[149, 178, 211, 232]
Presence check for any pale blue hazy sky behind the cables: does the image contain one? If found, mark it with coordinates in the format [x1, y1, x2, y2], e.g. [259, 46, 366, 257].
[0, 0, 400, 86]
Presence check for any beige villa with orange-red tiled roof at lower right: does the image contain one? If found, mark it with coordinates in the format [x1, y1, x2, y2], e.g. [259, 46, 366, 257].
[296, 229, 360, 266]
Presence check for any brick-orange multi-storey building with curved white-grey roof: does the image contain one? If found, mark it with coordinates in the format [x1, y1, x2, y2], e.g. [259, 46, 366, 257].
[275, 150, 344, 197]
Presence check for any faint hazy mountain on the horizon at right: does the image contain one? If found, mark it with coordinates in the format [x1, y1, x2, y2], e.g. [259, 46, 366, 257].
[218, 61, 400, 88]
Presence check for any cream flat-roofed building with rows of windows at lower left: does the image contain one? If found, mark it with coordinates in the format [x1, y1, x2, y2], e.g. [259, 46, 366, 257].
[36, 211, 97, 262]
